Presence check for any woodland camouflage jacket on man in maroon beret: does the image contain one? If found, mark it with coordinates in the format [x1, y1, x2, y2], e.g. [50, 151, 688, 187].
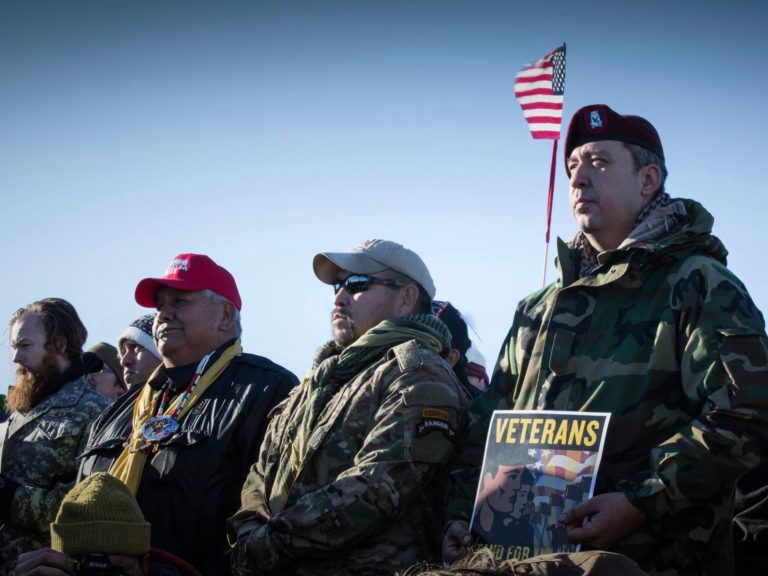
[451, 200, 768, 576]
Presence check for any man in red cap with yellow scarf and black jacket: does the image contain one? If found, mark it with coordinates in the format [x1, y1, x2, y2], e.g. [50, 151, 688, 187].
[80, 254, 296, 576]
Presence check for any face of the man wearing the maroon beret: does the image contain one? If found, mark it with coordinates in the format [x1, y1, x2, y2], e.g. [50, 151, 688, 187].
[568, 140, 647, 251]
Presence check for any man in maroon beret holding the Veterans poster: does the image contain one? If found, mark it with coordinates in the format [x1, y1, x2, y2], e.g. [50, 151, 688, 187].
[444, 104, 768, 576]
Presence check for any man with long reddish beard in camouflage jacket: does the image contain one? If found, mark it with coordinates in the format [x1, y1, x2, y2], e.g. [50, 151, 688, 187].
[0, 298, 110, 575]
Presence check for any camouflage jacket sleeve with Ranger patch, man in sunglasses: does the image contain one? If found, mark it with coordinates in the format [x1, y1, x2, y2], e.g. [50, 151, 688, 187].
[232, 362, 464, 575]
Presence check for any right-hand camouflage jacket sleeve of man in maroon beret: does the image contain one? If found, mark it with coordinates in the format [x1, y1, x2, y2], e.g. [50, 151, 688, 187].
[626, 264, 768, 520]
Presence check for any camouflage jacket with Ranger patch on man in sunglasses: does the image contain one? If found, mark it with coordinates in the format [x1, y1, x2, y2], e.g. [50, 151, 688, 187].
[230, 340, 468, 576]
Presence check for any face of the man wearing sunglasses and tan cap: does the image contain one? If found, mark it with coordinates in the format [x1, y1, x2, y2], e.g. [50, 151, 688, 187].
[331, 270, 401, 347]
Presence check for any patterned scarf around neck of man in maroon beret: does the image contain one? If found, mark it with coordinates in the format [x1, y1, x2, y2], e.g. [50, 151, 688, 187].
[571, 192, 689, 278]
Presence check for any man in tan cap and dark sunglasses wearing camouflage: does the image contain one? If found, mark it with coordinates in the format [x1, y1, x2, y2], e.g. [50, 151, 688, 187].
[230, 240, 467, 576]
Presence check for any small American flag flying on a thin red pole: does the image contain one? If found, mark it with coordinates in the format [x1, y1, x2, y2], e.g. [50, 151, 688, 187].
[515, 44, 565, 140]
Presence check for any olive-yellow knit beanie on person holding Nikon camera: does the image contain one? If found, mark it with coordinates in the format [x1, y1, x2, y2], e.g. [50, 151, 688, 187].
[51, 472, 150, 557]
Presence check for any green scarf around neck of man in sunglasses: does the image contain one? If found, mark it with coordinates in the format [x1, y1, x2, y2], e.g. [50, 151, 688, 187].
[269, 314, 451, 514]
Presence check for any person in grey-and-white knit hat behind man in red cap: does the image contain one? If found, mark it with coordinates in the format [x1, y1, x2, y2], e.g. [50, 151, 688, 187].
[117, 314, 163, 388]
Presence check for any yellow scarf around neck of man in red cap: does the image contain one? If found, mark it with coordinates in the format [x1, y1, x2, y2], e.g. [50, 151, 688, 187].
[109, 340, 243, 496]
